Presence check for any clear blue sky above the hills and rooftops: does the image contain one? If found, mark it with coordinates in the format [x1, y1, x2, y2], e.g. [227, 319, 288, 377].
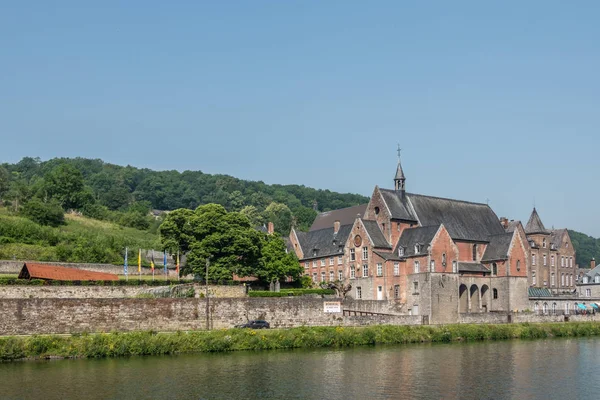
[0, 0, 600, 237]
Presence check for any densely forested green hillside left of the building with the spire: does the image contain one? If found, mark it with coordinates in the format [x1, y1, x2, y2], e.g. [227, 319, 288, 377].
[0, 157, 368, 233]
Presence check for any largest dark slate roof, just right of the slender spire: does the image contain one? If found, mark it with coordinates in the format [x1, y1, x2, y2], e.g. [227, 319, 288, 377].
[406, 193, 504, 242]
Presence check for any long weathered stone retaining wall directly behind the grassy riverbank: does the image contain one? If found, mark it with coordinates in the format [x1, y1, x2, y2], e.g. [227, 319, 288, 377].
[0, 298, 421, 335]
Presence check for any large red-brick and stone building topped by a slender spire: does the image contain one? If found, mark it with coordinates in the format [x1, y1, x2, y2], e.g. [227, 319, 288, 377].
[290, 154, 530, 323]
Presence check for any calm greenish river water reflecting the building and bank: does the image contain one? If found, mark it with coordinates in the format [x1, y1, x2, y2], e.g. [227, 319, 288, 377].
[0, 338, 600, 400]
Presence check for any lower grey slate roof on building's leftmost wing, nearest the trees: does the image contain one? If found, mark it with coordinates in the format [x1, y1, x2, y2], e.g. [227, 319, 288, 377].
[296, 225, 352, 259]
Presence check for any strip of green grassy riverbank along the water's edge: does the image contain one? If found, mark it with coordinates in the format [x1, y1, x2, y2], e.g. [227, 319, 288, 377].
[0, 322, 600, 361]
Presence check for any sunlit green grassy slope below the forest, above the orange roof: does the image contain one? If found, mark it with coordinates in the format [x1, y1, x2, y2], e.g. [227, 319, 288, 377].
[0, 208, 158, 264]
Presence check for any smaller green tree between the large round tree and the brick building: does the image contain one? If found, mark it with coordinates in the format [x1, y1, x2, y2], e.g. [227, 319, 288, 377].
[256, 235, 303, 282]
